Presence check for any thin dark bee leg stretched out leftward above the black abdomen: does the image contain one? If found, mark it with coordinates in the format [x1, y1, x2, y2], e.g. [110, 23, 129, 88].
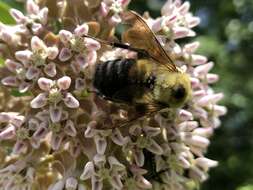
[84, 35, 150, 58]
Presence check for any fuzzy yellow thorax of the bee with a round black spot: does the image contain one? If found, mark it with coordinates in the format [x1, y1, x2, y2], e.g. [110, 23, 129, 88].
[154, 73, 191, 108]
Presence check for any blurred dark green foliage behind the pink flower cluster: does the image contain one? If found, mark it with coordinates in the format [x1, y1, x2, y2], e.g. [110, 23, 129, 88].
[0, 0, 253, 190]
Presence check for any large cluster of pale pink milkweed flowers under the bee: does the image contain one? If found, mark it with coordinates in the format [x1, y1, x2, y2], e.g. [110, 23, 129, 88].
[0, 0, 226, 190]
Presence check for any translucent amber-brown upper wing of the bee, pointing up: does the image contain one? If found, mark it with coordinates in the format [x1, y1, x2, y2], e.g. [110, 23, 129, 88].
[122, 11, 177, 72]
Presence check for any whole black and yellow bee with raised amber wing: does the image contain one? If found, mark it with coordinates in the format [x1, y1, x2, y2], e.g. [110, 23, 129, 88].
[86, 11, 191, 121]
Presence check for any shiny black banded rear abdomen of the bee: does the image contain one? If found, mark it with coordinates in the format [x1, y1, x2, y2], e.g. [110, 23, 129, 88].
[93, 59, 136, 98]
